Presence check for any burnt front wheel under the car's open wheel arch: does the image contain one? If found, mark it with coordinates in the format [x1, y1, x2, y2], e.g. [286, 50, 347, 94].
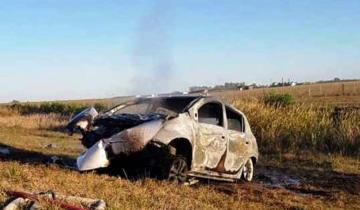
[168, 156, 188, 184]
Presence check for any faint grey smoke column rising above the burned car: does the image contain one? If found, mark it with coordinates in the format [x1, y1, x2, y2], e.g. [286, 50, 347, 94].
[132, 0, 174, 94]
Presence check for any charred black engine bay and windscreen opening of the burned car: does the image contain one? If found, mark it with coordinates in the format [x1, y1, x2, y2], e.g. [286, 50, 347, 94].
[81, 96, 198, 148]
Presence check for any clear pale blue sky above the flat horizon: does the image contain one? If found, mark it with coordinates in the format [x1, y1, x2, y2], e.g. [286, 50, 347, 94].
[0, 0, 360, 102]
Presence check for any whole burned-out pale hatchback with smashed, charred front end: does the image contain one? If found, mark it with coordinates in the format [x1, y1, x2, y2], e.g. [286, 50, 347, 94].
[67, 95, 258, 182]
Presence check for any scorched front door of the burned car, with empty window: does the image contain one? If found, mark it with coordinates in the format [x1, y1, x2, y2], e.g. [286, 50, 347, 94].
[193, 102, 227, 171]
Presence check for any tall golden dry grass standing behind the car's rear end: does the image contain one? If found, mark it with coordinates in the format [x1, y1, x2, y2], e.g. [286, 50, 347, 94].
[233, 100, 360, 157]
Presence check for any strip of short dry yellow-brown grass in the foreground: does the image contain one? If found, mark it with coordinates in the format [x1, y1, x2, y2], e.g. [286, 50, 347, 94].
[0, 162, 359, 209]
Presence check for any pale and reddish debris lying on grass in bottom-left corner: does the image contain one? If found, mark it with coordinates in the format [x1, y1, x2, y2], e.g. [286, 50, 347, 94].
[3, 191, 106, 210]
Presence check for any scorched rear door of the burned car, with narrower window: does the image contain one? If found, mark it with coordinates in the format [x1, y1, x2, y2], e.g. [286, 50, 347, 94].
[224, 106, 249, 173]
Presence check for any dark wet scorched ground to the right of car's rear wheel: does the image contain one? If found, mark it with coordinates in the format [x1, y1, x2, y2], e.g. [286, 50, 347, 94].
[210, 159, 360, 209]
